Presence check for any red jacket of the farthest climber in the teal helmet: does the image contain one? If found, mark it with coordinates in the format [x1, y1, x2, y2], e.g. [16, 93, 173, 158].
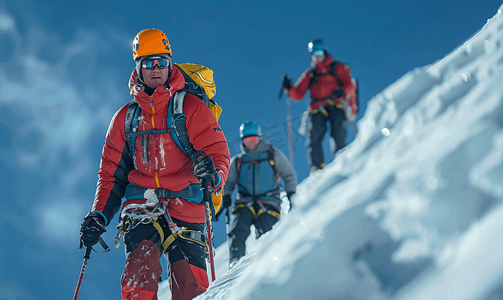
[288, 54, 356, 110]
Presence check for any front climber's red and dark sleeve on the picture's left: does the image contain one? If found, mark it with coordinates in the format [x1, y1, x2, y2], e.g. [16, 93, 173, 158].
[92, 103, 134, 224]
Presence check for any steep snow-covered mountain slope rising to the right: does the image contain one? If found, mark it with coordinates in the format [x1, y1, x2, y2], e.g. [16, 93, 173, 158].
[159, 6, 503, 300]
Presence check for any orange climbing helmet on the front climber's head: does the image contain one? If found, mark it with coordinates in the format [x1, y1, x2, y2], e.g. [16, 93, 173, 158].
[133, 28, 171, 61]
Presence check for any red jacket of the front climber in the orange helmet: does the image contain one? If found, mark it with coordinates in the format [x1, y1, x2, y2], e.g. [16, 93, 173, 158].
[92, 68, 230, 223]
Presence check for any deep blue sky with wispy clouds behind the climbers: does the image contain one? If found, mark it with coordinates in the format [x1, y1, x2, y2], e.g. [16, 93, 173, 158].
[0, 0, 501, 299]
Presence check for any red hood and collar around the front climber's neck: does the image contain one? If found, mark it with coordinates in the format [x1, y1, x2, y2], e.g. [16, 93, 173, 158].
[129, 67, 185, 113]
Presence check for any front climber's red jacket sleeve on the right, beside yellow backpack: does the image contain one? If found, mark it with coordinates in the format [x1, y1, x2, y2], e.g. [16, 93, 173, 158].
[184, 94, 230, 188]
